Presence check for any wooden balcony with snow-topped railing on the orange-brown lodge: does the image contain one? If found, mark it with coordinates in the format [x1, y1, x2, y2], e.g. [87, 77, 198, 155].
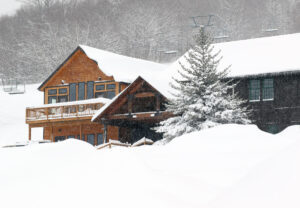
[26, 98, 110, 124]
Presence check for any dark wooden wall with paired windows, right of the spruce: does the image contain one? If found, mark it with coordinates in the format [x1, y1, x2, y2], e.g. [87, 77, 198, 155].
[234, 74, 300, 133]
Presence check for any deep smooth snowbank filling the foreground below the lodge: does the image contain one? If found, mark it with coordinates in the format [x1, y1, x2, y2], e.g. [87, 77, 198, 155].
[0, 125, 300, 208]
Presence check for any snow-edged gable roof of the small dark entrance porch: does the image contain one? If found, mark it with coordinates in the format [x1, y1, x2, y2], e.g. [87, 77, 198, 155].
[91, 76, 167, 122]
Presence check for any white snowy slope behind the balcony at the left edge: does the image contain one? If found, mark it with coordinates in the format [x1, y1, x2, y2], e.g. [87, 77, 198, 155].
[0, 84, 43, 146]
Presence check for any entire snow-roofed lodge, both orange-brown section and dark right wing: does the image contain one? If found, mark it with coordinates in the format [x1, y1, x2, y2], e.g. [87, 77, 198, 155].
[26, 34, 300, 145]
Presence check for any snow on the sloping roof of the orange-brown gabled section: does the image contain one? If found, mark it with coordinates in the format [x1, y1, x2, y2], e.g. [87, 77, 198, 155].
[79, 45, 173, 96]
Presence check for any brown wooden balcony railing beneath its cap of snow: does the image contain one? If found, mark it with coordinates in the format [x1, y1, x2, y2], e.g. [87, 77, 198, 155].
[26, 103, 103, 122]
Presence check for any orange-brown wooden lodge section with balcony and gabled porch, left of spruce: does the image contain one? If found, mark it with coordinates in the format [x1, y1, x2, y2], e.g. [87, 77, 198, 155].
[26, 46, 169, 145]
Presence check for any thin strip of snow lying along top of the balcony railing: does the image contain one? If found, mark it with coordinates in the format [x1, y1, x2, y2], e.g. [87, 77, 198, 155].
[29, 98, 111, 108]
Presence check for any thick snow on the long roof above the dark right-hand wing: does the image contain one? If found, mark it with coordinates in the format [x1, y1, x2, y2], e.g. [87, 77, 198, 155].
[171, 33, 300, 77]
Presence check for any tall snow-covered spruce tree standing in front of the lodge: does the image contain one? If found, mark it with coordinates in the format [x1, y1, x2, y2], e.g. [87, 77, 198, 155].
[156, 28, 250, 142]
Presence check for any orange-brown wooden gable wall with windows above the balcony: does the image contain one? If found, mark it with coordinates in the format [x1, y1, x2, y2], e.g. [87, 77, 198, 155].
[41, 50, 128, 104]
